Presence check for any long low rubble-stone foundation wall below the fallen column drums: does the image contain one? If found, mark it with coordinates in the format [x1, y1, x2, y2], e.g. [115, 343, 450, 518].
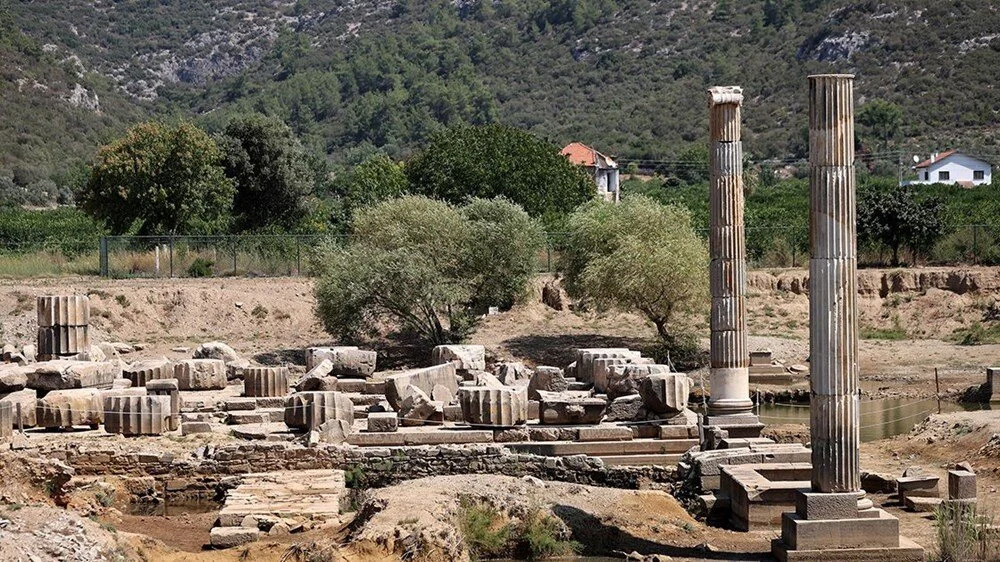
[42, 443, 675, 489]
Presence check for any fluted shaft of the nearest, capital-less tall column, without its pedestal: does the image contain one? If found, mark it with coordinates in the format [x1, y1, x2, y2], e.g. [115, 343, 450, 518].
[809, 74, 861, 492]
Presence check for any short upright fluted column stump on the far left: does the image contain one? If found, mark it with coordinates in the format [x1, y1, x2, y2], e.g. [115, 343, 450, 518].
[36, 295, 90, 360]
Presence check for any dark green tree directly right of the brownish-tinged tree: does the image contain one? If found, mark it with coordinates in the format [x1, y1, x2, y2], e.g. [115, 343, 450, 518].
[218, 114, 313, 230]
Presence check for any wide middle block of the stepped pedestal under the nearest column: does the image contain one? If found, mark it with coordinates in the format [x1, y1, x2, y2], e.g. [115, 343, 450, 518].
[781, 506, 899, 550]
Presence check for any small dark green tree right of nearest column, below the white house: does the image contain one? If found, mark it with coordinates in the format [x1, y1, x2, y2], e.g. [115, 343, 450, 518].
[857, 182, 945, 266]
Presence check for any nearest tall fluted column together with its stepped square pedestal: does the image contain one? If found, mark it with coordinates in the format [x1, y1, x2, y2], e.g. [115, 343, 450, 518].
[771, 74, 924, 562]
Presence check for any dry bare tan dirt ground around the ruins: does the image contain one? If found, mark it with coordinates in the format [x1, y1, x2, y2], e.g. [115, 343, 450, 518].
[0, 268, 1000, 561]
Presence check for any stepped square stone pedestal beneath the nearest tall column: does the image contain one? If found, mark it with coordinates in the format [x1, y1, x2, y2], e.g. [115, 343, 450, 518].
[771, 492, 924, 562]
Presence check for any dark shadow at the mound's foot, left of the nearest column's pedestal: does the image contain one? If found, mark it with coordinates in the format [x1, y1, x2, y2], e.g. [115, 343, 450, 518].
[552, 505, 774, 561]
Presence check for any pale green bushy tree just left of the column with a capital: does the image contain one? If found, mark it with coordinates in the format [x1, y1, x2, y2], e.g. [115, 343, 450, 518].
[560, 196, 709, 347]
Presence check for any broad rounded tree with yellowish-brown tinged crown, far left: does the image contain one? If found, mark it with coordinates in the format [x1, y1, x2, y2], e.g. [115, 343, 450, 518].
[76, 121, 233, 234]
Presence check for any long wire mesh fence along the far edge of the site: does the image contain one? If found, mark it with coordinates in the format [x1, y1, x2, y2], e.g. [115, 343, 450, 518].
[0, 224, 1000, 278]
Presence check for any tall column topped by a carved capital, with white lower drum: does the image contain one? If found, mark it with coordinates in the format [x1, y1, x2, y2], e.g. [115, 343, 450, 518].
[708, 86, 756, 421]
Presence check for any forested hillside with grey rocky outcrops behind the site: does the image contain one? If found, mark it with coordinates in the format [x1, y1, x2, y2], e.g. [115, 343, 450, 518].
[0, 0, 1000, 200]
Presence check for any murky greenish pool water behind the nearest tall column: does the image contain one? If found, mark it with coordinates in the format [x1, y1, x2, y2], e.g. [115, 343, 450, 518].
[760, 398, 984, 441]
